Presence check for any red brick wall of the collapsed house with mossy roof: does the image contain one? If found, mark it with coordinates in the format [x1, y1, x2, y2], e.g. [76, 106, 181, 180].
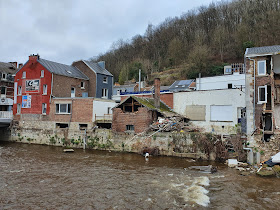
[112, 107, 153, 133]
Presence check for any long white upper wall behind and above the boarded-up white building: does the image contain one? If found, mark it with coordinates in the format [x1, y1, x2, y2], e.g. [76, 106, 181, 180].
[196, 73, 245, 90]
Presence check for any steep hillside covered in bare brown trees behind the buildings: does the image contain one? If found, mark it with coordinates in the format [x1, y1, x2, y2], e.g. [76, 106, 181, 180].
[96, 0, 280, 85]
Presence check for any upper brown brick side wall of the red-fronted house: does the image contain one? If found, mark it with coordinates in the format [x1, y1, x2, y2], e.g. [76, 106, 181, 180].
[52, 74, 89, 98]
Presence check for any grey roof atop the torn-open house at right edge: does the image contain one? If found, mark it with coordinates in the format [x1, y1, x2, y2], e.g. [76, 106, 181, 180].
[245, 45, 280, 57]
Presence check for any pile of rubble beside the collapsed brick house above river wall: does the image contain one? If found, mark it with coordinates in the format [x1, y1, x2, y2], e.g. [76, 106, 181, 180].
[150, 116, 199, 132]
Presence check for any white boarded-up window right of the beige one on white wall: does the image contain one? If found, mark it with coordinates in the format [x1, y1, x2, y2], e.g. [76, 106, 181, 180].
[210, 105, 233, 122]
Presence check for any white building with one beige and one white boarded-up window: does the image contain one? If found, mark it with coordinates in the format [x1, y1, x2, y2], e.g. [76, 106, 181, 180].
[173, 88, 246, 134]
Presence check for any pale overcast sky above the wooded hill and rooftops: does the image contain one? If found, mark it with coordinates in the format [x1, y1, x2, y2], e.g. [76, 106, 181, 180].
[0, 0, 217, 65]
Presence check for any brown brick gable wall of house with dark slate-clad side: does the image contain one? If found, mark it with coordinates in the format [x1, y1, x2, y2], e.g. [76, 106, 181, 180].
[72, 61, 96, 97]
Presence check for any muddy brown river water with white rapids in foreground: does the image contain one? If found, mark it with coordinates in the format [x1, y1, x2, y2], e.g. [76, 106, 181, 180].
[0, 142, 280, 209]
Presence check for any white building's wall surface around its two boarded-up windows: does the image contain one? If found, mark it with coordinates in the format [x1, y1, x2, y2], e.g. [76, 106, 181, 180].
[174, 89, 245, 134]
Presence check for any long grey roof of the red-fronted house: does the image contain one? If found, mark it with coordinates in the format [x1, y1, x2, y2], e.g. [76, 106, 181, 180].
[38, 58, 89, 80]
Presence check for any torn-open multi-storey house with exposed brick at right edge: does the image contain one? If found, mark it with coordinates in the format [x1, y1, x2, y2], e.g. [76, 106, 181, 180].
[245, 45, 280, 145]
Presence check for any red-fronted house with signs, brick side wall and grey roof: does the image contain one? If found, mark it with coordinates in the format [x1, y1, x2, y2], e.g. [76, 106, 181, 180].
[13, 55, 89, 120]
